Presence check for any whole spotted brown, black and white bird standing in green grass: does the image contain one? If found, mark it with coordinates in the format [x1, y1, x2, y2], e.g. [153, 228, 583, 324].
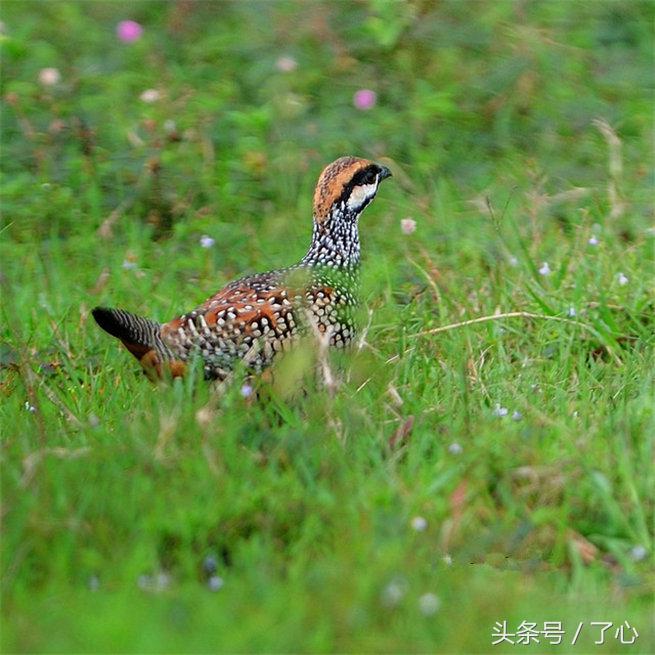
[92, 156, 391, 381]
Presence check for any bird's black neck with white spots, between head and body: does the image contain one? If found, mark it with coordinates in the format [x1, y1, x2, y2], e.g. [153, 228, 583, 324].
[302, 211, 360, 271]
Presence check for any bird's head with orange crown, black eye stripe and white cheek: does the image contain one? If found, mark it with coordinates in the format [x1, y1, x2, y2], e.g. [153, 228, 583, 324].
[314, 157, 391, 225]
